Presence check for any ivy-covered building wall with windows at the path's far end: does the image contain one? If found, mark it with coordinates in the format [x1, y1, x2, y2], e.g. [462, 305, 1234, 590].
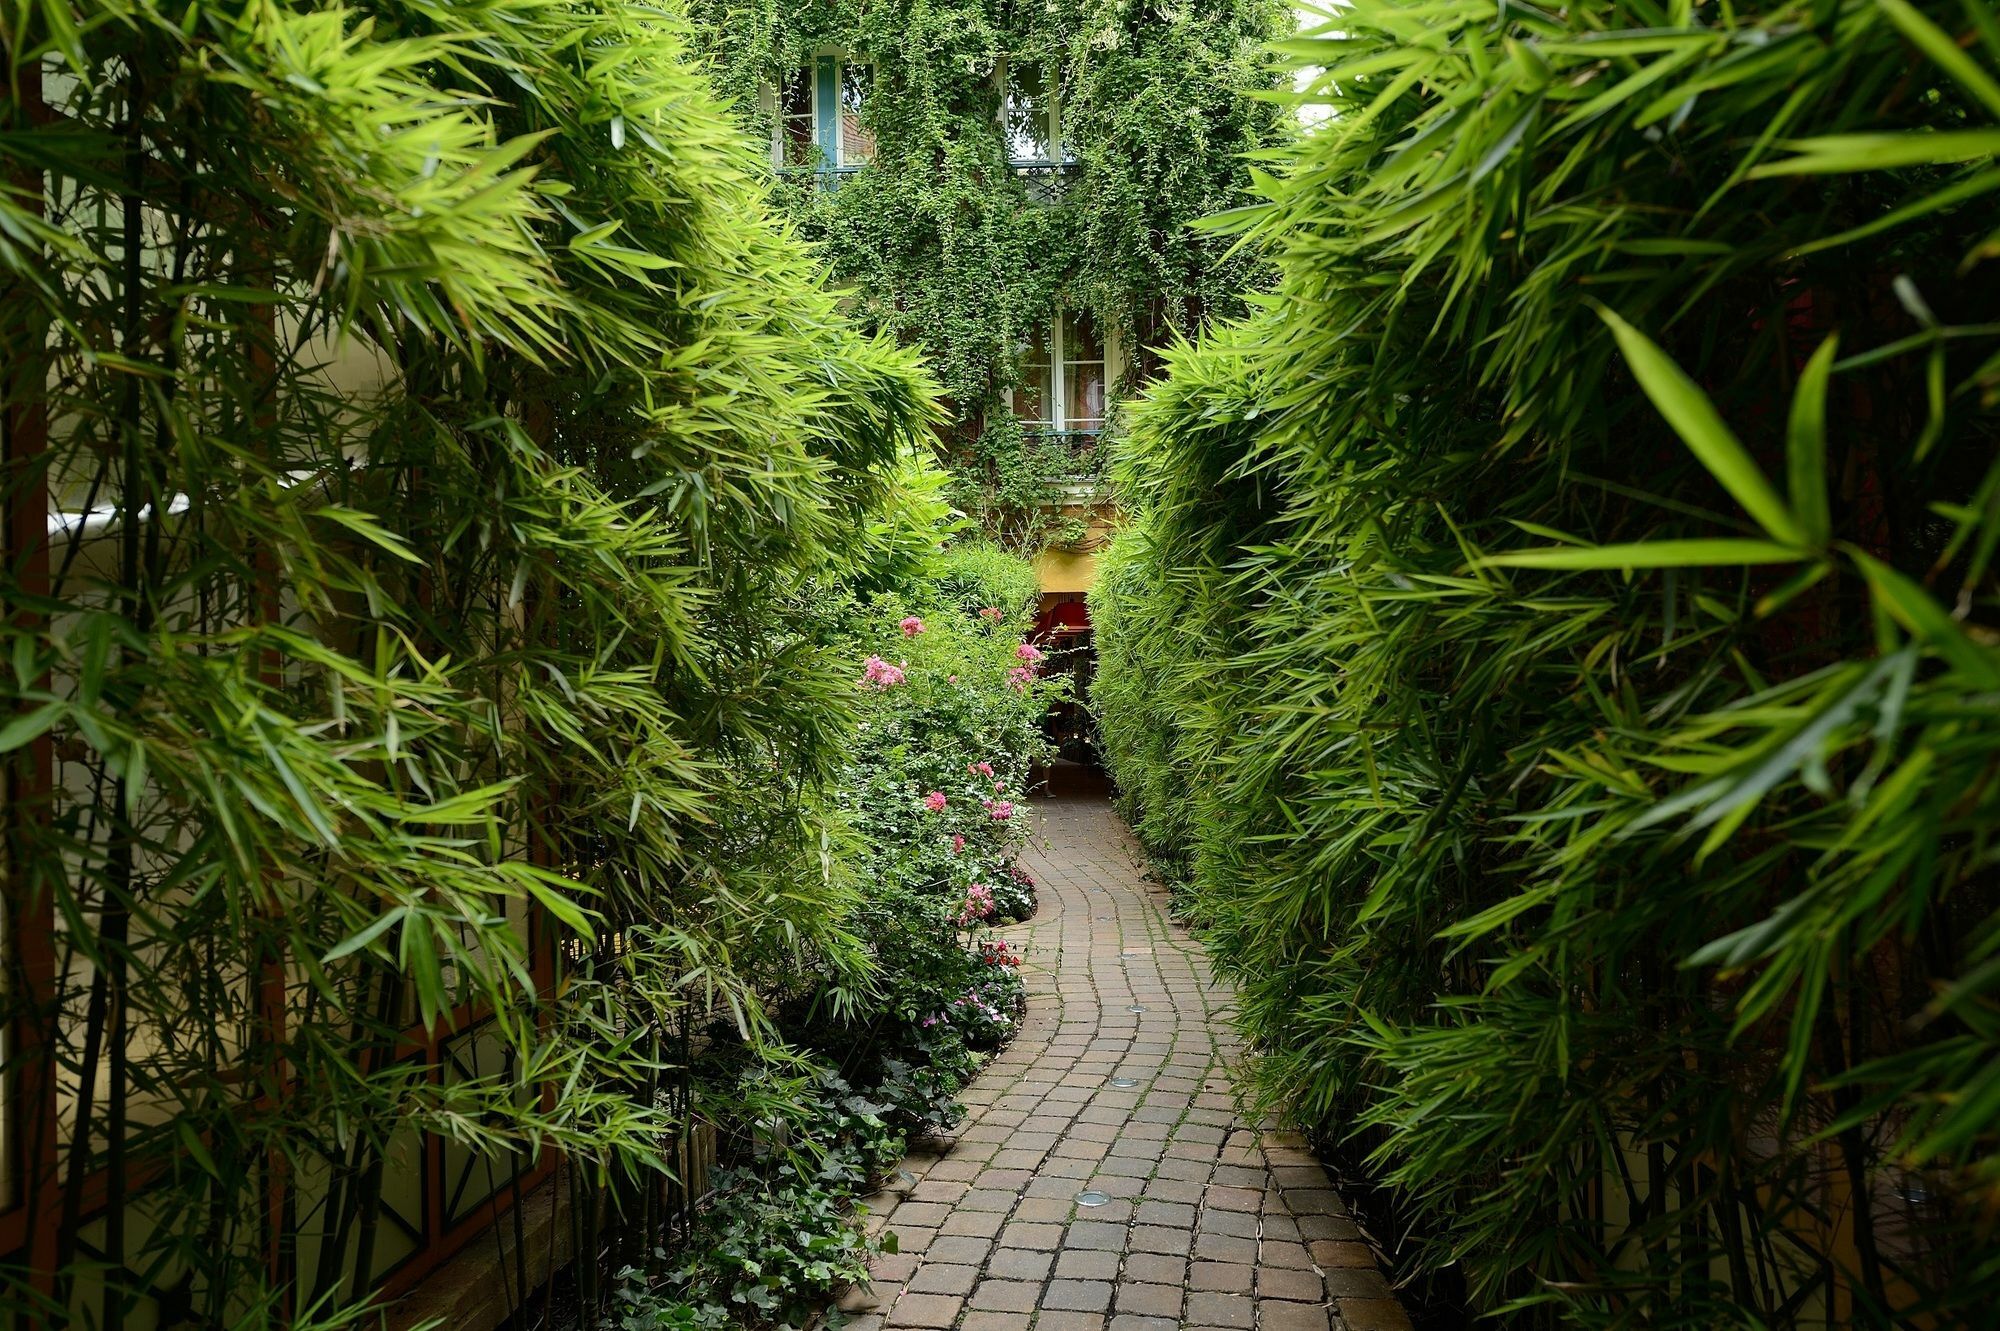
[690, 0, 1294, 546]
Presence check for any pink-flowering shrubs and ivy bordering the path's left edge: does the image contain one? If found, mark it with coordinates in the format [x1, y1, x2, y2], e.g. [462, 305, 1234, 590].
[616, 546, 1060, 1331]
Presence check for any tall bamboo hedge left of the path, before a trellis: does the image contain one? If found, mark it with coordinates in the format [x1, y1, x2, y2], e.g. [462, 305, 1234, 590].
[0, 0, 936, 1327]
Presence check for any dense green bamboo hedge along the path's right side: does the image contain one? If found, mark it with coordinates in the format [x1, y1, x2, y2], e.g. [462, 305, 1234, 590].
[1092, 0, 2000, 1327]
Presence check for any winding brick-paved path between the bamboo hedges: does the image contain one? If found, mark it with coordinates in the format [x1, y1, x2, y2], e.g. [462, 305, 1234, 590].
[842, 795, 1410, 1331]
